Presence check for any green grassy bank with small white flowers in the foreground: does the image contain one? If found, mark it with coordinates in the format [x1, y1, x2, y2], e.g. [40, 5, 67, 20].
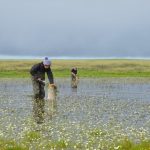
[0, 131, 150, 150]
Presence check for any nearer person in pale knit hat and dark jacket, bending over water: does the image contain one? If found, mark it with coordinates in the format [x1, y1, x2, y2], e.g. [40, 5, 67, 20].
[30, 57, 55, 99]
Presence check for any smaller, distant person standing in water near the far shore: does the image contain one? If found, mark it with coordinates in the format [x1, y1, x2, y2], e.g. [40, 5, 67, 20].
[71, 67, 78, 88]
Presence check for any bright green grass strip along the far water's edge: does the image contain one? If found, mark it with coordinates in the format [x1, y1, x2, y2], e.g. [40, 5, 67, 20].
[0, 69, 150, 78]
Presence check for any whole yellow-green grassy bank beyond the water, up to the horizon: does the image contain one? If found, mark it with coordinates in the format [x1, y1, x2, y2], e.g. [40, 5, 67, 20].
[0, 60, 150, 78]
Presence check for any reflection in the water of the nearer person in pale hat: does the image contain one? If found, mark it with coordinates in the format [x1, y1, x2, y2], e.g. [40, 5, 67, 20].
[33, 99, 45, 124]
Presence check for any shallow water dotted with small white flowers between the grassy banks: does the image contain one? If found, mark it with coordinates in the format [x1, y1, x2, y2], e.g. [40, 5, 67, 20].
[0, 78, 150, 143]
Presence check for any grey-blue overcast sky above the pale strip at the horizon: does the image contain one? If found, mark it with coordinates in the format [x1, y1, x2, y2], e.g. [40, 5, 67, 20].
[0, 0, 150, 57]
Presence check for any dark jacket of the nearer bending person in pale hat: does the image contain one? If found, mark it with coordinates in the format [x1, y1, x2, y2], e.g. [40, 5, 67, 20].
[30, 62, 54, 84]
